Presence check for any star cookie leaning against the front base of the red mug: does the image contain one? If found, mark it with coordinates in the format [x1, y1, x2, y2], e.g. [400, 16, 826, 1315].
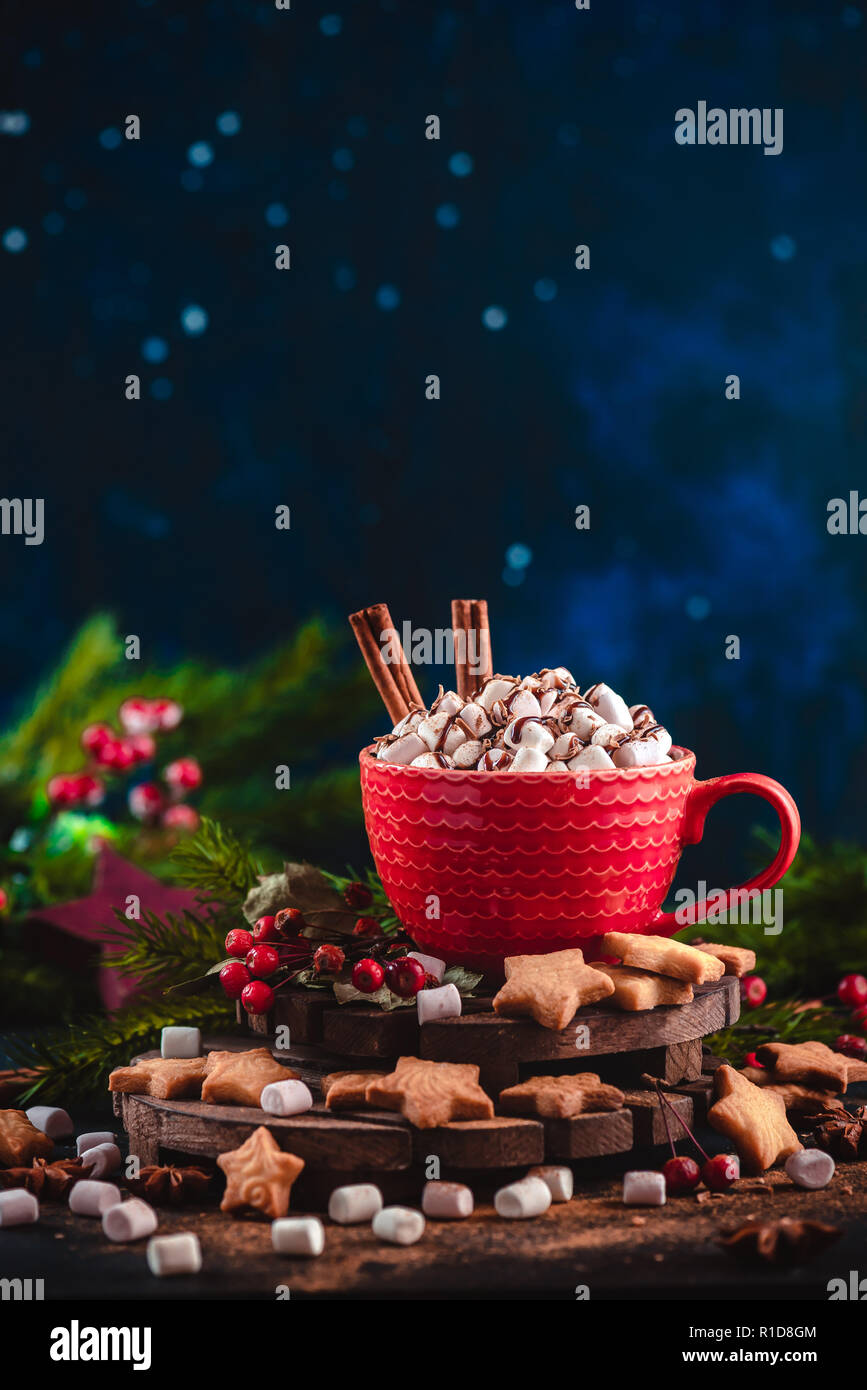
[493, 949, 614, 1031]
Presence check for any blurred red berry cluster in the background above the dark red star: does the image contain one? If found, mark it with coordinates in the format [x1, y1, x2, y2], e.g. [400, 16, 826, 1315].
[47, 695, 201, 831]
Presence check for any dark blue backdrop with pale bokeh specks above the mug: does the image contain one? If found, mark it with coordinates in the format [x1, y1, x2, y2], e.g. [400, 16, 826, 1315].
[0, 0, 867, 867]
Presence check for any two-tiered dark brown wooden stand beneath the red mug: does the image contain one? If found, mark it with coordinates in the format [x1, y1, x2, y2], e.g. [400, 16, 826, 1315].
[114, 976, 739, 1208]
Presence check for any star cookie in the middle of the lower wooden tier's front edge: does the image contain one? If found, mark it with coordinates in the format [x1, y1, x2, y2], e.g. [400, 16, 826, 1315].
[365, 1056, 493, 1129]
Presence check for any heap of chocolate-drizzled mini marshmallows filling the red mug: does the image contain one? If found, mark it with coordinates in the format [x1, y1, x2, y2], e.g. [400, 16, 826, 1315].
[377, 666, 679, 773]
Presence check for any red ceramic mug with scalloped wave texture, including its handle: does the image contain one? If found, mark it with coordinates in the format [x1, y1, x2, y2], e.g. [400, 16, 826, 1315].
[360, 749, 800, 970]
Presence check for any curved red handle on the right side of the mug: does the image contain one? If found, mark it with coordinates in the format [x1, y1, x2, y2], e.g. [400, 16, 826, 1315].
[647, 773, 800, 937]
